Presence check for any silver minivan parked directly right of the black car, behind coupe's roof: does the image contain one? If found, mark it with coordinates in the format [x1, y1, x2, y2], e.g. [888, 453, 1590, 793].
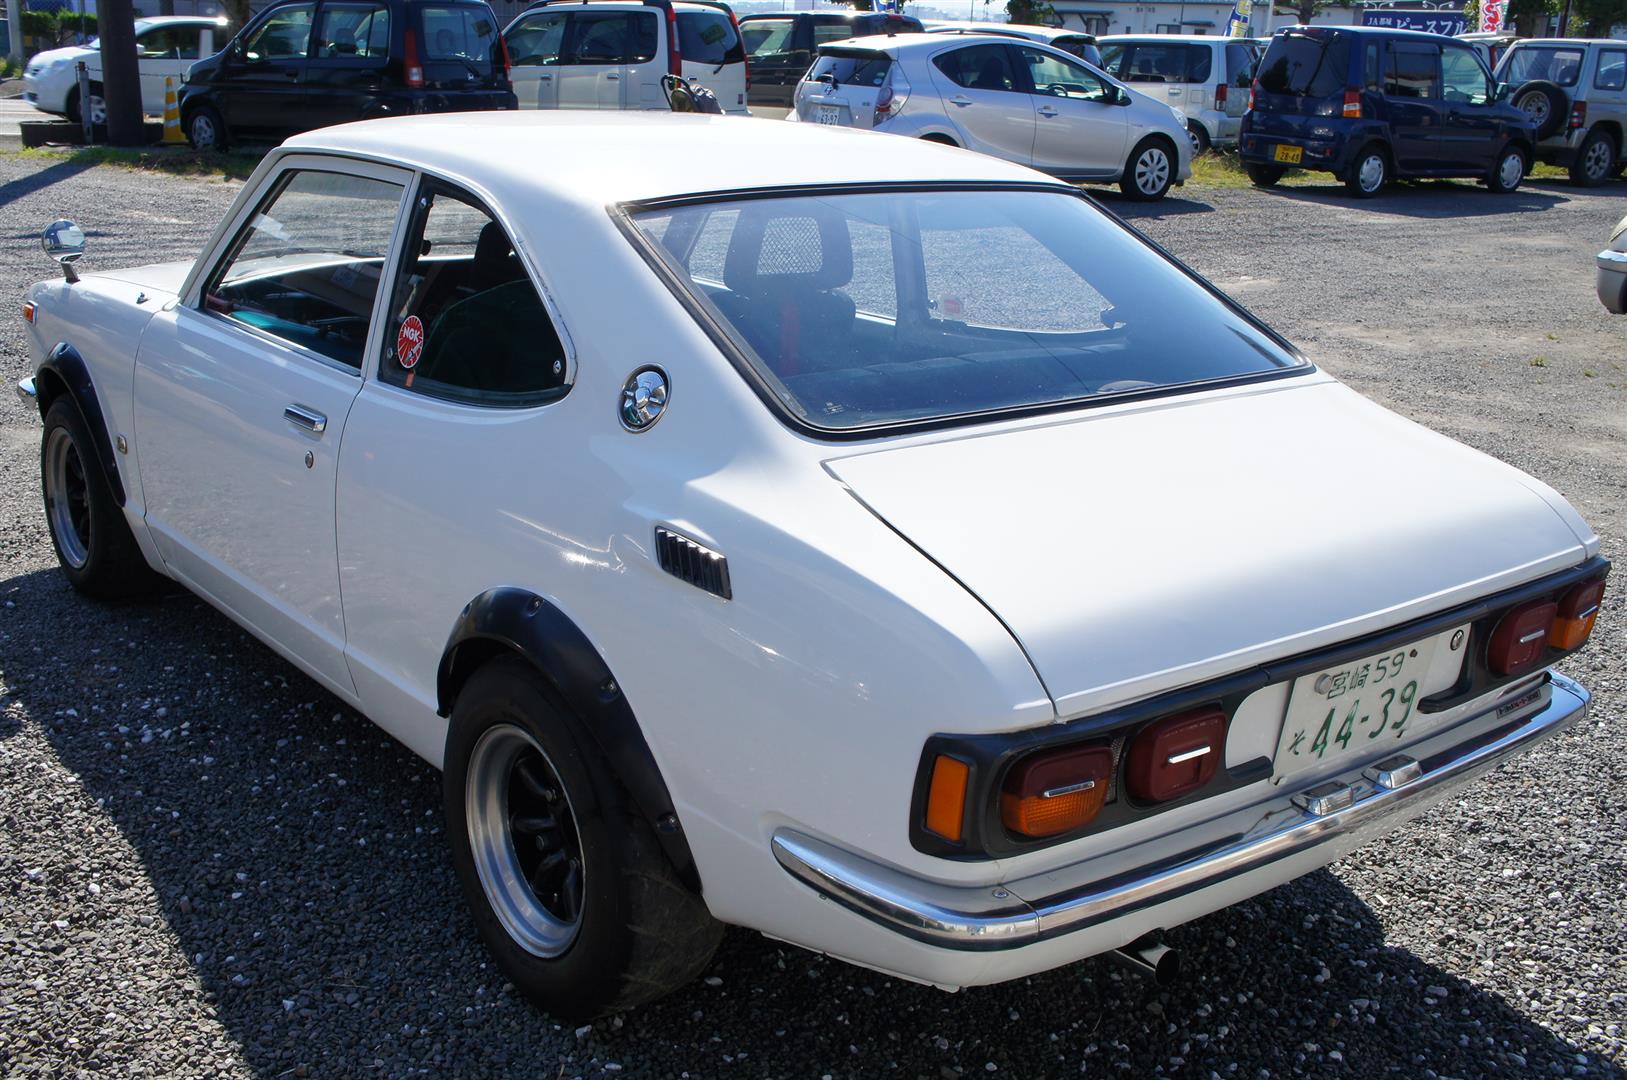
[503, 0, 750, 115]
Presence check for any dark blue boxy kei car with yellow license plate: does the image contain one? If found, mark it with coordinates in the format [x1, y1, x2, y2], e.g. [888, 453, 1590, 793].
[1240, 26, 1536, 198]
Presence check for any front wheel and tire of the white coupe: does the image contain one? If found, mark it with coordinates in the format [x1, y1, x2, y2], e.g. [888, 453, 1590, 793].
[39, 397, 164, 600]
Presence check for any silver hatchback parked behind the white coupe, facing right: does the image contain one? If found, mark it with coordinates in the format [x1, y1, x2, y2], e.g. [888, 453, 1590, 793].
[786, 34, 1193, 200]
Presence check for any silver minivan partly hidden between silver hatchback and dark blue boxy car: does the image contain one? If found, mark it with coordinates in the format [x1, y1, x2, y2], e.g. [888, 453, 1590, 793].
[1098, 34, 1259, 155]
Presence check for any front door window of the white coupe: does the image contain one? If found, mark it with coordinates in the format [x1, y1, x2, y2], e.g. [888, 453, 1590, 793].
[203, 169, 402, 371]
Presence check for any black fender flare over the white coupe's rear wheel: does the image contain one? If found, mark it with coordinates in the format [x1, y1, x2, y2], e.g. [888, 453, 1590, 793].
[434, 587, 701, 895]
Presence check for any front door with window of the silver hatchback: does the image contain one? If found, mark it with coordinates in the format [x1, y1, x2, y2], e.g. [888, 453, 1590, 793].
[1015, 46, 1129, 177]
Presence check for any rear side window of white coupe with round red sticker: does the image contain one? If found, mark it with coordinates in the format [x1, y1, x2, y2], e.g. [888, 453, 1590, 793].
[379, 185, 566, 407]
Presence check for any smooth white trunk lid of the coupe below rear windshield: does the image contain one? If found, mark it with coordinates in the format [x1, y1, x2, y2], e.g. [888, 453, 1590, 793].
[827, 376, 1596, 717]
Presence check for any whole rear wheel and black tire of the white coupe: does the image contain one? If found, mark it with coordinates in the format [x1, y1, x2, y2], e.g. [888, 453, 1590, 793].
[443, 657, 722, 1021]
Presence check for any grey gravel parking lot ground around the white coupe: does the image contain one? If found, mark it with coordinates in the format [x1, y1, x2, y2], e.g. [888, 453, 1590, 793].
[0, 156, 1627, 1077]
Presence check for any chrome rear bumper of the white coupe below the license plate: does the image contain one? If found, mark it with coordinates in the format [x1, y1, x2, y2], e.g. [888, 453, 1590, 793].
[773, 673, 1590, 950]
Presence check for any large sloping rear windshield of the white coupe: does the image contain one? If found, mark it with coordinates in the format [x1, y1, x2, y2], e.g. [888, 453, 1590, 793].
[633, 190, 1303, 431]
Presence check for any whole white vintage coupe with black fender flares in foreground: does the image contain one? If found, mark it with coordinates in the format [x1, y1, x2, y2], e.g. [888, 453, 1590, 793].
[21, 112, 1609, 1017]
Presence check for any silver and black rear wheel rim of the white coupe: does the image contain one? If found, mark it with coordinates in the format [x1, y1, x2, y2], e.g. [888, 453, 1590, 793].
[464, 724, 584, 958]
